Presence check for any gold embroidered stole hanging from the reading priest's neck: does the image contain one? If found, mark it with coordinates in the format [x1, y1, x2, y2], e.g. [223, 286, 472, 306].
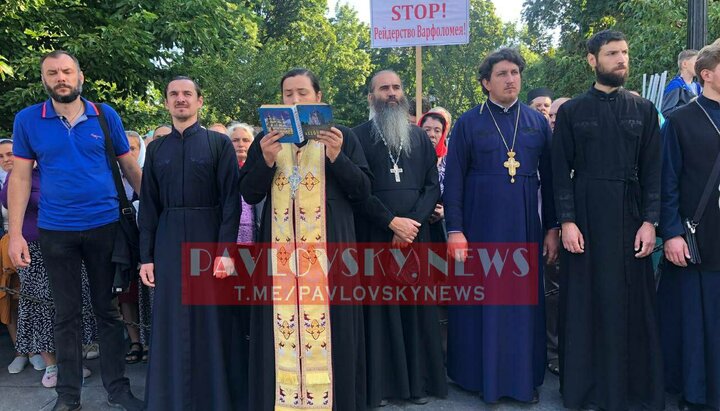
[272, 140, 333, 411]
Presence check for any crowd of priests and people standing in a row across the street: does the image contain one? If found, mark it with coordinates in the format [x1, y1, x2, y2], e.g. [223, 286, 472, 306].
[0, 30, 720, 411]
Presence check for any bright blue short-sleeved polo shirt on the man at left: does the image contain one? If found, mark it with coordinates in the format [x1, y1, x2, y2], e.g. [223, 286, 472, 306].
[13, 99, 130, 231]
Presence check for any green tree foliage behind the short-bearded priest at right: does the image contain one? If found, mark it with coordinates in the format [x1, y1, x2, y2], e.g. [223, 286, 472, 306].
[523, 0, 720, 100]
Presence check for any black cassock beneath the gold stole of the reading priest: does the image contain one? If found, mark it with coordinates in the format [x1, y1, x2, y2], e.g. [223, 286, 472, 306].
[240, 125, 370, 411]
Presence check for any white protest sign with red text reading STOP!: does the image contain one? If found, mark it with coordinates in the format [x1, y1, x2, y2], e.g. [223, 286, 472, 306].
[370, 0, 470, 48]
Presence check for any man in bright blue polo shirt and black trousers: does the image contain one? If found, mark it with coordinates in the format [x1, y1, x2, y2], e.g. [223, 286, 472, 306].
[8, 50, 143, 411]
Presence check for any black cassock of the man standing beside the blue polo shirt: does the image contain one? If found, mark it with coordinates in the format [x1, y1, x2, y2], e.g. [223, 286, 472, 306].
[138, 123, 246, 411]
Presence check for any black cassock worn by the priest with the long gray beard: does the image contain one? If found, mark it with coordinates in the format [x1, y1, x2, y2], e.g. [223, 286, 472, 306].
[353, 121, 447, 407]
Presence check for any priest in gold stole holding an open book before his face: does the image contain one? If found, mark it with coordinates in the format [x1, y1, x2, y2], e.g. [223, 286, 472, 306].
[240, 68, 370, 411]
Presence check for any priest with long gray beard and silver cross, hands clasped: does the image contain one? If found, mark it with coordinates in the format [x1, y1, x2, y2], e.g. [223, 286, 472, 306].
[353, 71, 447, 407]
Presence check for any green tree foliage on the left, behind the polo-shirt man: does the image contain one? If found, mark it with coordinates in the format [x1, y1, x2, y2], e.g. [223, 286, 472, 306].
[0, 0, 370, 132]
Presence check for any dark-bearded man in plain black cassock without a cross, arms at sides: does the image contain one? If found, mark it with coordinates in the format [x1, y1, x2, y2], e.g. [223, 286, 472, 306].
[552, 30, 664, 411]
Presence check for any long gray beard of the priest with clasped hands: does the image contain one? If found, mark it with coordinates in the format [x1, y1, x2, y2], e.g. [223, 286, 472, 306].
[372, 97, 412, 155]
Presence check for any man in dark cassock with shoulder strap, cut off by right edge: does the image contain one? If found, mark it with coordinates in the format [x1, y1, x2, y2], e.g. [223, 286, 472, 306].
[658, 45, 720, 411]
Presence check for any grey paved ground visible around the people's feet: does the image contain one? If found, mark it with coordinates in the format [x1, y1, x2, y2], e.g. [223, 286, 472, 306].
[0, 328, 563, 411]
